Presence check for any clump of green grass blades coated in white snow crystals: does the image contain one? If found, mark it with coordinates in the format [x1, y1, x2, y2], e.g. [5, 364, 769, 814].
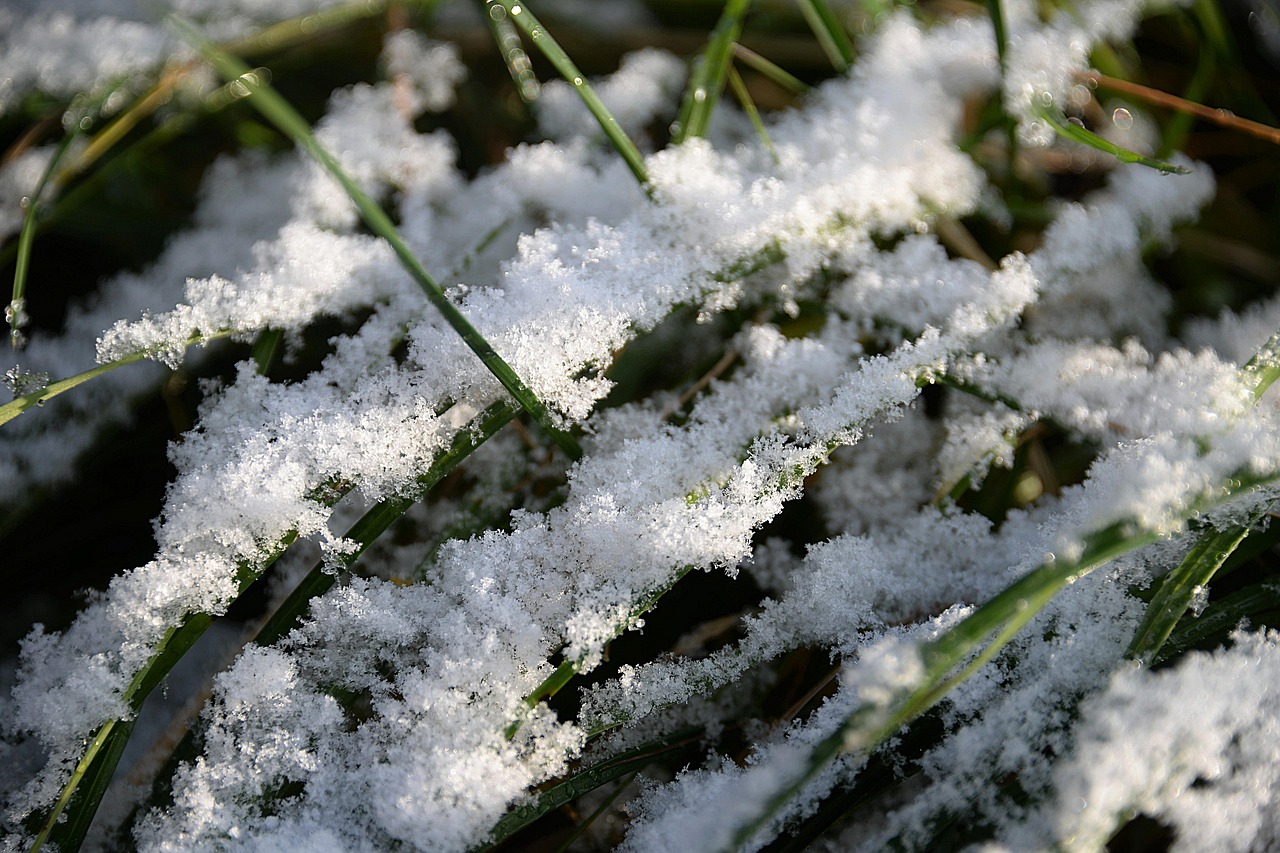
[0, 0, 1280, 850]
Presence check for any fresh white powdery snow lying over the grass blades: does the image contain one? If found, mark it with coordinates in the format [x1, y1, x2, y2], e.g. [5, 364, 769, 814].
[0, 0, 1280, 853]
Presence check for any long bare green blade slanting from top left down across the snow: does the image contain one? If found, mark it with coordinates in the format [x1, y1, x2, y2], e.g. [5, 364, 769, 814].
[169, 15, 582, 460]
